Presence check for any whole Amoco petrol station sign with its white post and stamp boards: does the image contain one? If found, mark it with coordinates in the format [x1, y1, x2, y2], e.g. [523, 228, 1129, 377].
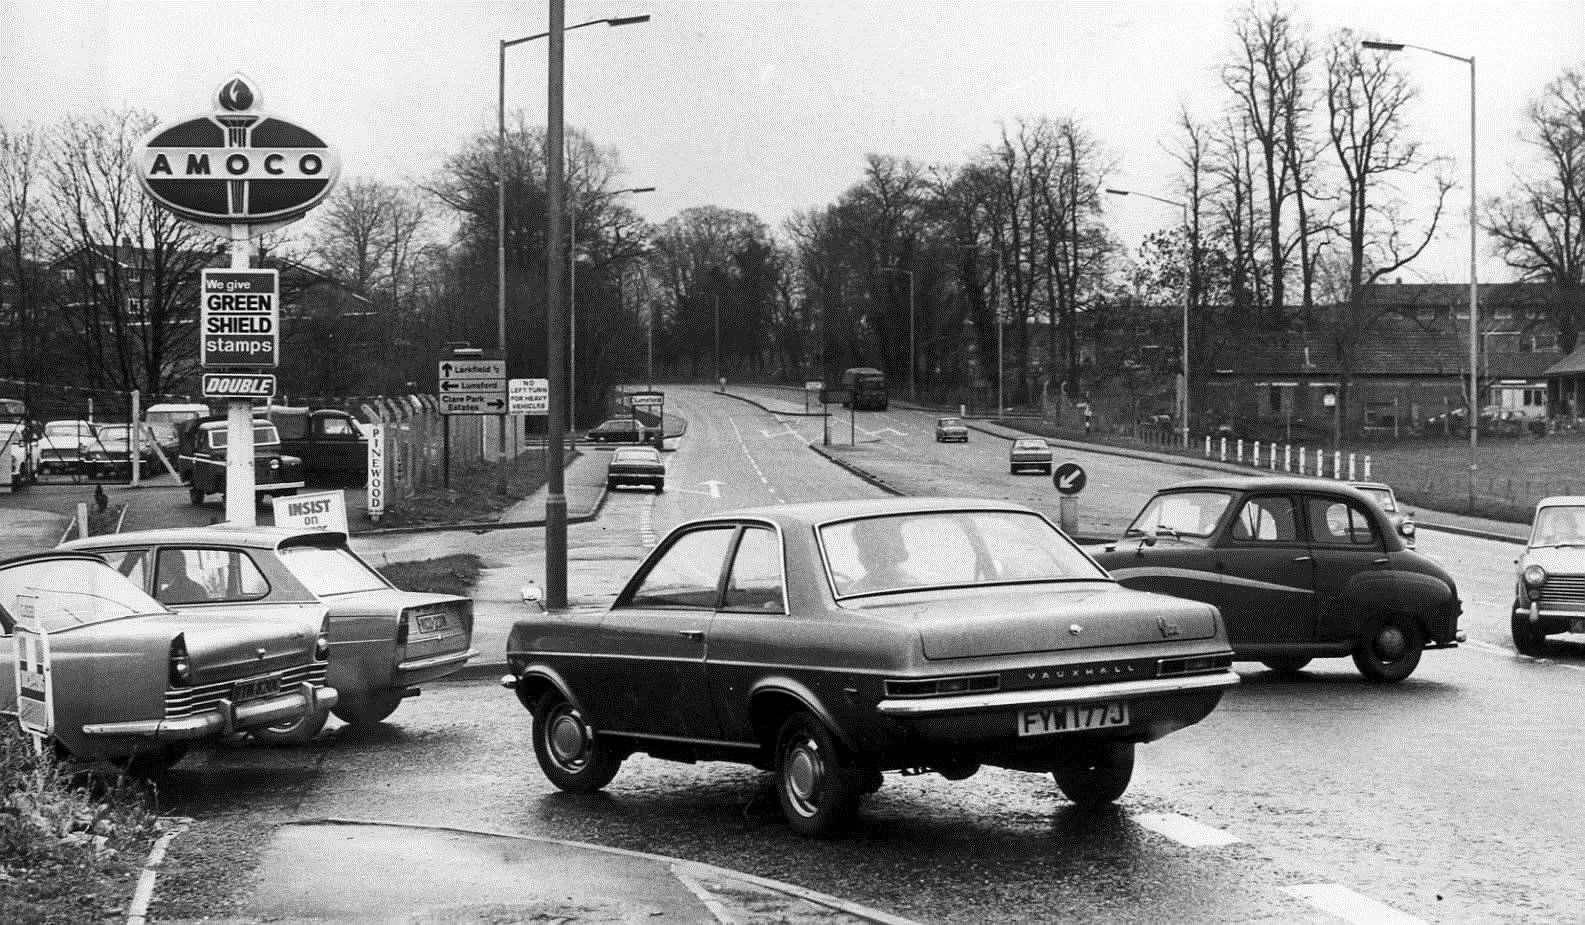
[135, 74, 341, 526]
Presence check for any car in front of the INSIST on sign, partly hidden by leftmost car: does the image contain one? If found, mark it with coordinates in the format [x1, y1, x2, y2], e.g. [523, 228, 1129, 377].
[65, 524, 477, 741]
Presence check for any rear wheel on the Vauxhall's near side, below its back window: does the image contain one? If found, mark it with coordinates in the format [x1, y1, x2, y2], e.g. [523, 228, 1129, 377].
[775, 713, 864, 838]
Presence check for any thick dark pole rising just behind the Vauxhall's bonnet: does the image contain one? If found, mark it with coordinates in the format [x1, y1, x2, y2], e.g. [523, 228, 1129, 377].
[545, 9, 650, 610]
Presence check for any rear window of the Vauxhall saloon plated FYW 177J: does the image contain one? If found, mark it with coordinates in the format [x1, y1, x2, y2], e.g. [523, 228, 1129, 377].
[819, 510, 1106, 597]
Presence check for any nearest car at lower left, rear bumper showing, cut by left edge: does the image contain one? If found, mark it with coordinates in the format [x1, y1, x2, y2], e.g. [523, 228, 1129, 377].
[0, 551, 336, 775]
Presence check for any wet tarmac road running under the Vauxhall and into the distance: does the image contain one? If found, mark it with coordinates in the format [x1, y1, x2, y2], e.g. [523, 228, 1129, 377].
[155, 388, 1585, 922]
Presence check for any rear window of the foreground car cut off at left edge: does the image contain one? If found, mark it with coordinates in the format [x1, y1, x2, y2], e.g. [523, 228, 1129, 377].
[0, 559, 165, 632]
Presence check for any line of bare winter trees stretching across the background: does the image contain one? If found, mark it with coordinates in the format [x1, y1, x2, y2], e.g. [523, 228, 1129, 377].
[0, 0, 1585, 423]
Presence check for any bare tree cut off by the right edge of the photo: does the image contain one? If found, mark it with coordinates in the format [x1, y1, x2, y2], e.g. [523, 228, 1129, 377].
[1487, 65, 1585, 353]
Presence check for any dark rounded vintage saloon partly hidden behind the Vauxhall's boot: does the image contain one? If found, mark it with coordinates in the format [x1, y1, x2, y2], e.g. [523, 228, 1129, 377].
[1090, 477, 1463, 681]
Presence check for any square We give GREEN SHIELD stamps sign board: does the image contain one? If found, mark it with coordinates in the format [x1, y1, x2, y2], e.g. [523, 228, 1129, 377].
[198, 269, 281, 369]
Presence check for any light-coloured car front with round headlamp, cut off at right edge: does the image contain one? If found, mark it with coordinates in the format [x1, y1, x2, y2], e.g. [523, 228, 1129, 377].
[1512, 496, 1585, 656]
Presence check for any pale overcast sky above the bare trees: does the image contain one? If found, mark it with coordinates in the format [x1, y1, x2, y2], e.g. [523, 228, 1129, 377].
[0, 0, 1585, 282]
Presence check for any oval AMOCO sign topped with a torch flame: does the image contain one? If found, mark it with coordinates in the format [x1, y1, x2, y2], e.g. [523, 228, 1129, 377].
[138, 74, 341, 234]
